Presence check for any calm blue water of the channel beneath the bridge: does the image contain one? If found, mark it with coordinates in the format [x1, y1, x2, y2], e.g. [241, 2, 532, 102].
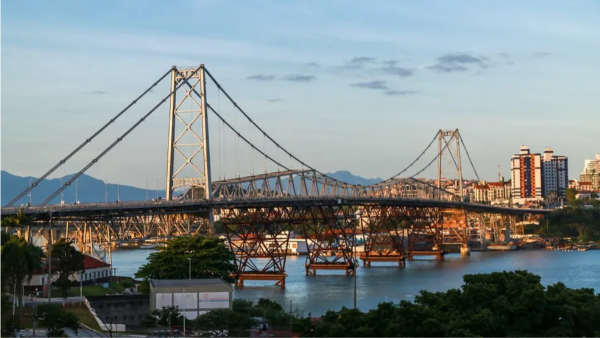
[113, 250, 600, 316]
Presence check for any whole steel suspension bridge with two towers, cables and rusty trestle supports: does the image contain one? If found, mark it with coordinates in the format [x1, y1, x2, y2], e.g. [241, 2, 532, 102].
[2, 65, 549, 287]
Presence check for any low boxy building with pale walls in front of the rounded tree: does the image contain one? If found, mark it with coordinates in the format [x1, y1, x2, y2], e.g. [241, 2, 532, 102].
[150, 278, 233, 319]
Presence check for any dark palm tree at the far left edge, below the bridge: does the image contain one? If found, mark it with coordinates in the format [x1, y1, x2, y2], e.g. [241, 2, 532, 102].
[2, 236, 44, 325]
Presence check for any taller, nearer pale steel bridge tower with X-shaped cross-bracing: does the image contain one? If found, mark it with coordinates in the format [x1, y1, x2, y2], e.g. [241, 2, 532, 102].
[165, 65, 212, 201]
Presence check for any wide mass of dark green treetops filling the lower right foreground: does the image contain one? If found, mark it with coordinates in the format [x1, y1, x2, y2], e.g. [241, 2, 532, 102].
[295, 271, 600, 337]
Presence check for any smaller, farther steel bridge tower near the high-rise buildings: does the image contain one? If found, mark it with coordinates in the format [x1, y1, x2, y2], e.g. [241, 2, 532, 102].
[437, 129, 465, 201]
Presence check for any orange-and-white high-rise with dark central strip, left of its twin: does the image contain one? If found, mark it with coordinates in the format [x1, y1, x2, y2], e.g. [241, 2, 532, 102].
[510, 146, 543, 204]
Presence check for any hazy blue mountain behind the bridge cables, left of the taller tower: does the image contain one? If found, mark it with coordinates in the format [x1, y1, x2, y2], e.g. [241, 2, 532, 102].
[0, 170, 165, 206]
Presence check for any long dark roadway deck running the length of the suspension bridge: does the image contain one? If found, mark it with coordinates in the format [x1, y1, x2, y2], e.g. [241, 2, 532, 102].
[1, 196, 552, 221]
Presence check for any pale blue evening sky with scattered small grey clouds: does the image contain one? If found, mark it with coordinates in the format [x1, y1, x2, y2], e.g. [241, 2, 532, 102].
[1, 0, 600, 188]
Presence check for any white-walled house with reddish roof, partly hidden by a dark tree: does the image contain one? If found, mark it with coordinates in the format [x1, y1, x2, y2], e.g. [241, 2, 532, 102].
[24, 255, 112, 287]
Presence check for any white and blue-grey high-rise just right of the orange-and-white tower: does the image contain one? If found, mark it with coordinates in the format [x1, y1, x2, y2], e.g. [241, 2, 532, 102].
[542, 148, 569, 197]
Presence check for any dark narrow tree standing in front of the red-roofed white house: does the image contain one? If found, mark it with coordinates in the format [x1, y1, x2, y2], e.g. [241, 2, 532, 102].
[52, 238, 84, 298]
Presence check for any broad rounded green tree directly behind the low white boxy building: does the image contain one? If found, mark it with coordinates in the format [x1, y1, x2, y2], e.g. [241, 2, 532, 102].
[135, 236, 237, 283]
